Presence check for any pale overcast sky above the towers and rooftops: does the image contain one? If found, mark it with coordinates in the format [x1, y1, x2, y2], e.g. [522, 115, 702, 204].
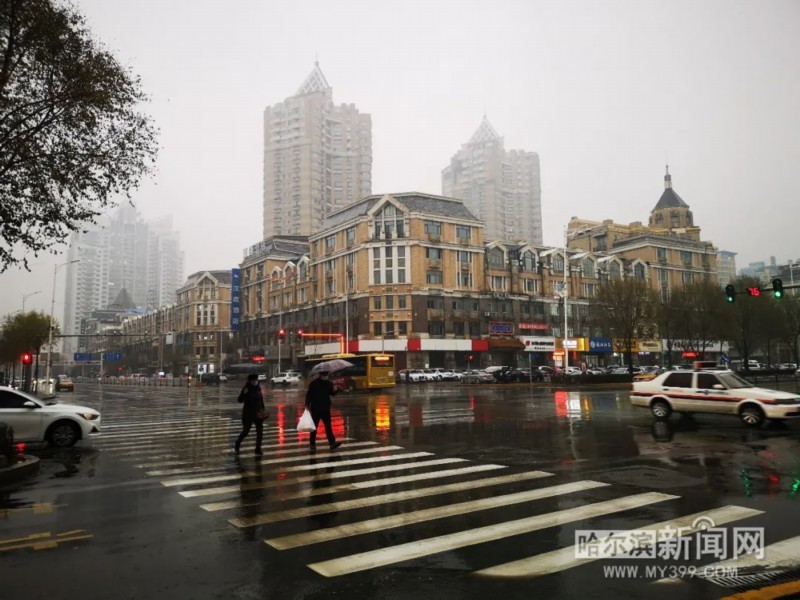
[0, 0, 800, 315]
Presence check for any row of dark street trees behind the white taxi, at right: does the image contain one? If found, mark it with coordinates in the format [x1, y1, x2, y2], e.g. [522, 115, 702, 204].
[590, 277, 800, 368]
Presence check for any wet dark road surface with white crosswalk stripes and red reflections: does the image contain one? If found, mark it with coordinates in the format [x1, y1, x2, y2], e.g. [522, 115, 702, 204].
[0, 382, 800, 599]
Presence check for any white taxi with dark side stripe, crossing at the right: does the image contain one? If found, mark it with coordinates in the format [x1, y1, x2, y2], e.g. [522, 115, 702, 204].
[631, 370, 800, 427]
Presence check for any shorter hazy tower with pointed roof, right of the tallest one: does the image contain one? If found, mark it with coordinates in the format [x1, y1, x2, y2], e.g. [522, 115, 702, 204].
[442, 117, 542, 244]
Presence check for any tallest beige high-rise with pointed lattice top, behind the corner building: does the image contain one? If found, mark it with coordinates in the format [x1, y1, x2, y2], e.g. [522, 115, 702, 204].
[264, 63, 372, 239]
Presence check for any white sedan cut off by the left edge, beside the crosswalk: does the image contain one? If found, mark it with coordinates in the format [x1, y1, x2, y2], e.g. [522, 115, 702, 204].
[0, 387, 100, 448]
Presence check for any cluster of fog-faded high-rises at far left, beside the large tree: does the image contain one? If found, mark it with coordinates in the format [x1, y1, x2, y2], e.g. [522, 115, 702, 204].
[63, 206, 183, 353]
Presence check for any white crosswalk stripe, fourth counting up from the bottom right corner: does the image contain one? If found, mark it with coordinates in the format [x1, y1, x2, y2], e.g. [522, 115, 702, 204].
[264, 481, 609, 550]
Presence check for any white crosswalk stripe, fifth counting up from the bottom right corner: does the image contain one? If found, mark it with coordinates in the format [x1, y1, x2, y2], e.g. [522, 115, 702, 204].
[228, 471, 550, 527]
